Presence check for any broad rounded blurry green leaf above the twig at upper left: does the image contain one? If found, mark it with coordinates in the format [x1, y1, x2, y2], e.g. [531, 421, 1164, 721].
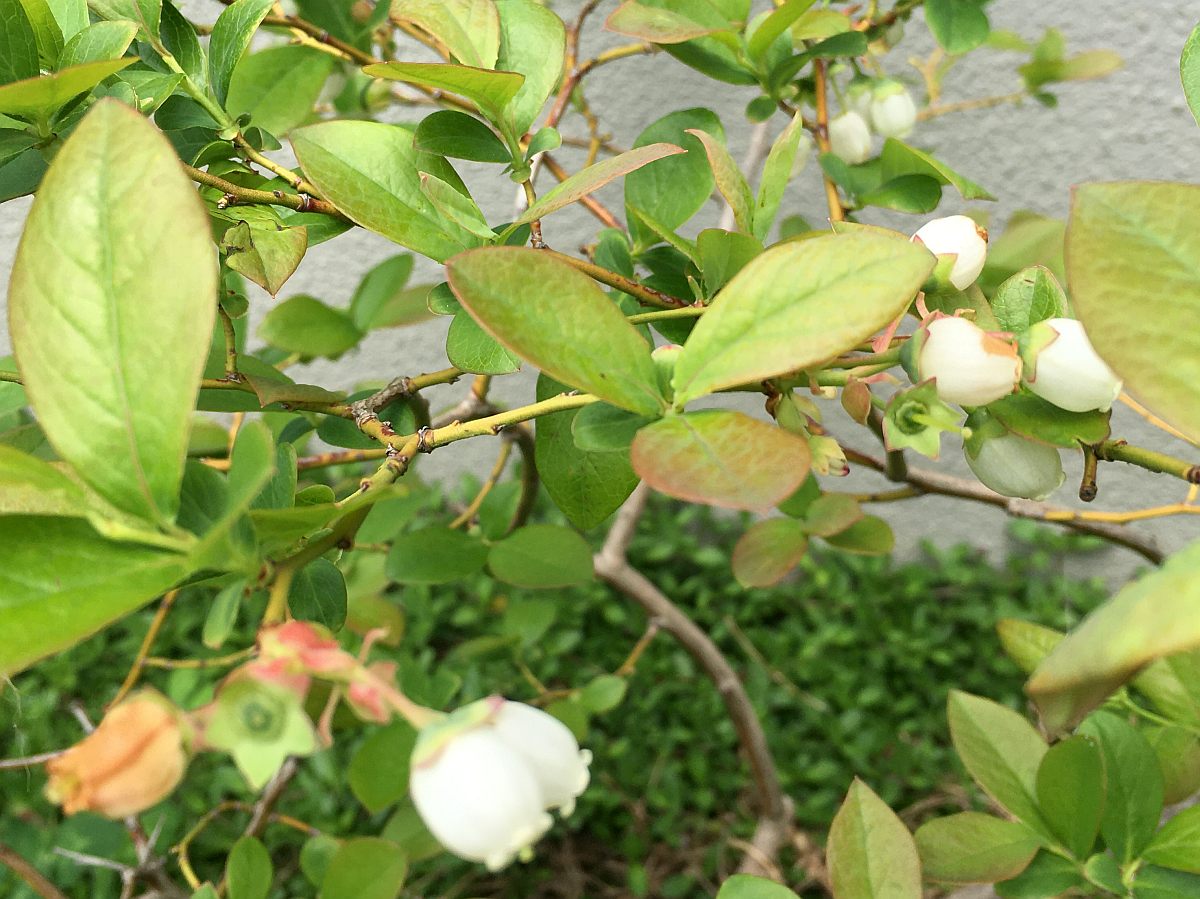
[226, 46, 334, 134]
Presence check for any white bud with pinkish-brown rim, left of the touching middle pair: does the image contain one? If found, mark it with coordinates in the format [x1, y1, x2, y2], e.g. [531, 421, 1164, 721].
[906, 316, 1021, 406]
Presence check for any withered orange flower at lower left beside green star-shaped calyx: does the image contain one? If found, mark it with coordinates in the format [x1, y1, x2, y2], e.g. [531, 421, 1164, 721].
[46, 690, 187, 819]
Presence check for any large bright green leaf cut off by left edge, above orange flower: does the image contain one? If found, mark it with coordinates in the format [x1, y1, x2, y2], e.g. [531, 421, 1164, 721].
[0, 515, 192, 675]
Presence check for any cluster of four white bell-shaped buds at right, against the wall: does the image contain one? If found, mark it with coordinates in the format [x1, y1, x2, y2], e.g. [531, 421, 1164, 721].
[910, 215, 1122, 499]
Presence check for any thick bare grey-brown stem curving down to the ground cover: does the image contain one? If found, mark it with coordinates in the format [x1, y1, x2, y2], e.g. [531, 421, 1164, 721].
[594, 483, 792, 873]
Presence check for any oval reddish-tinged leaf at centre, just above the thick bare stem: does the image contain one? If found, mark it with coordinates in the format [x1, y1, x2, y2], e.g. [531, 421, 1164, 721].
[630, 409, 809, 510]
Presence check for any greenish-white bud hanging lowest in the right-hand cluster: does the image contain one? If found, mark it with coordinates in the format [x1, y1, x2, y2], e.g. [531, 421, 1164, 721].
[962, 412, 1067, 499]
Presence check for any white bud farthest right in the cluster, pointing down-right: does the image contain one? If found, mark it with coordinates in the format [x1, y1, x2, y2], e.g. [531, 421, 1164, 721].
[1021, 318, 1122, 412]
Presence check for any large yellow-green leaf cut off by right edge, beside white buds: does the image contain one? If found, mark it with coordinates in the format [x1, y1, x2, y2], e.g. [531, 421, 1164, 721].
[1067, 181, 1200, 439]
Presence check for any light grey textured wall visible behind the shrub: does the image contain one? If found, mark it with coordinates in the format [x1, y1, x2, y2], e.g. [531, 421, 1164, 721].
[0, 0, 1200, 579]
